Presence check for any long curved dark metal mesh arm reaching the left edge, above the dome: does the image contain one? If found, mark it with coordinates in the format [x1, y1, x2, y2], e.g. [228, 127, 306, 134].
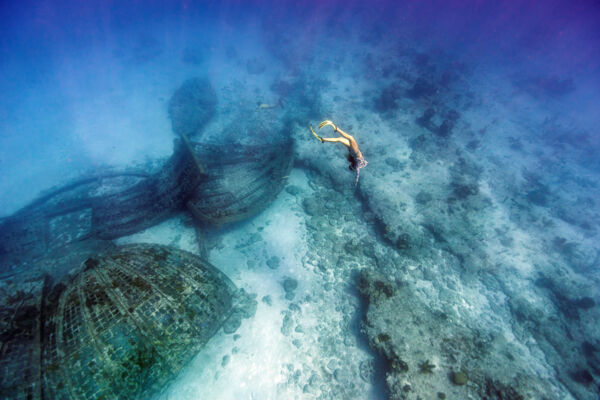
[0, 146, 200, 276]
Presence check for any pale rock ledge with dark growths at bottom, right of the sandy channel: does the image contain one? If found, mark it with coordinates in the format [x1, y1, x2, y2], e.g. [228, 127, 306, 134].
[357, 270, 557, 400]
